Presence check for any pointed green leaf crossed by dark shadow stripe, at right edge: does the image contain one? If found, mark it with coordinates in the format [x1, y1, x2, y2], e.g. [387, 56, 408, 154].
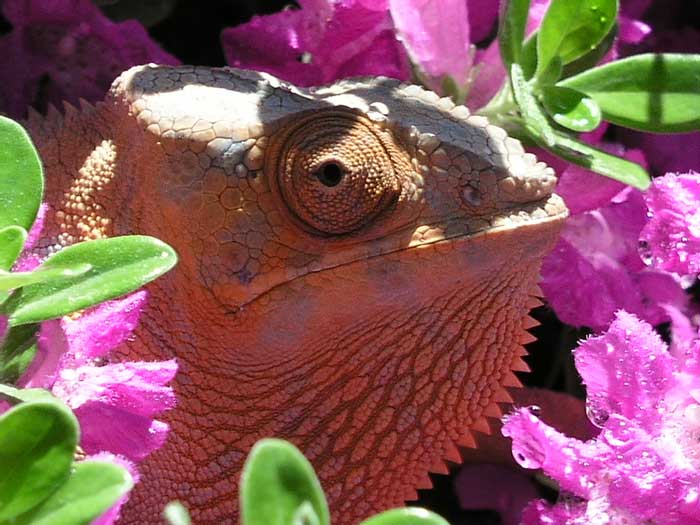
[558, 53, 700, 133]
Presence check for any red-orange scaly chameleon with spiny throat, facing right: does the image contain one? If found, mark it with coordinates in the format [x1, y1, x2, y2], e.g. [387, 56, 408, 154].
[28, 65, 566, 525]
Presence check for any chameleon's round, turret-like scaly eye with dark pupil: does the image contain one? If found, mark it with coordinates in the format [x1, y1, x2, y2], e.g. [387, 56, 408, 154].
[272, 110, 399, 235]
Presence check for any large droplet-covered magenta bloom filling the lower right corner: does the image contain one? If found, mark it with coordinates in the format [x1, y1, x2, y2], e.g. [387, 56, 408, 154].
[503, 312, 700, 525]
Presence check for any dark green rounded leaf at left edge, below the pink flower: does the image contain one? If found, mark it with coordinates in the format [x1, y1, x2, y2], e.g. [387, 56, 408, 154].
[0, 401, 78, 522]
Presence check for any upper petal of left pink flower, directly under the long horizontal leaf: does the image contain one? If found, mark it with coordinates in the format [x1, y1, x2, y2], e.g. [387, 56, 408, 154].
[63, 290, 148, 366]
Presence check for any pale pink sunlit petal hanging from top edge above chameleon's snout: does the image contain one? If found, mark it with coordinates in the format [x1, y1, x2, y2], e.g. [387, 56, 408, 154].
[389, 0, 471, 89]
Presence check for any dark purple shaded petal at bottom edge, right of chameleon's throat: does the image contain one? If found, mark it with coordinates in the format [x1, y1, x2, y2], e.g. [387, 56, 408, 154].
[455, 463, 537, 525]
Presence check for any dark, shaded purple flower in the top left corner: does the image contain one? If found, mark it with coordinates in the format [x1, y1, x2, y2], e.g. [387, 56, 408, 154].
[0, 0, 179, 117]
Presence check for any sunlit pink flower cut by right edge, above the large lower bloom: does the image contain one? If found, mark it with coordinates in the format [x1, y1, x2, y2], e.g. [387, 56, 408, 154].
[640, 171, 700, 275]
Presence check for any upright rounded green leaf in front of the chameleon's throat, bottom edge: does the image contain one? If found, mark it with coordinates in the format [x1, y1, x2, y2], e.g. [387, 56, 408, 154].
[240, 439, 330, 525]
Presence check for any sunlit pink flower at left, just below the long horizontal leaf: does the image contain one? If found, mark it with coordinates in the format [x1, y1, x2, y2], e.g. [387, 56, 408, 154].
[18, 292, 177, 462]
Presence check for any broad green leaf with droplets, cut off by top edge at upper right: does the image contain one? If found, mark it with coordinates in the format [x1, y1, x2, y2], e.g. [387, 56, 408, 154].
[537, 0, 617, 76]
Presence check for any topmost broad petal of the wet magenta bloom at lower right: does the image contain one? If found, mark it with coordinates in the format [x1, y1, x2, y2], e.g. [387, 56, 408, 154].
[575, 312, 673, 432]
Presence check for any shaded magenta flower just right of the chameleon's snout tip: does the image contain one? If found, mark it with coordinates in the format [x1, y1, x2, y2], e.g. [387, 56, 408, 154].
[541, 156, 687, 330]
